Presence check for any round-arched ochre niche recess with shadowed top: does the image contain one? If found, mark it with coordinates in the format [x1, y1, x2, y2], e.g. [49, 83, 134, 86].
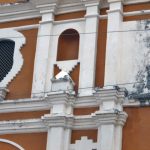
[57, 29, 80, 61]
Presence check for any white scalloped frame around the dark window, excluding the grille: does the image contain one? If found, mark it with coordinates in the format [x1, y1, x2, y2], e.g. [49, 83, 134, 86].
[0, 29, 26, 87]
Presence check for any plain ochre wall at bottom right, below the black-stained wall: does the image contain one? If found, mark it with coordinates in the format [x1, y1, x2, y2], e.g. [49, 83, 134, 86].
[122, 107, 150, 150]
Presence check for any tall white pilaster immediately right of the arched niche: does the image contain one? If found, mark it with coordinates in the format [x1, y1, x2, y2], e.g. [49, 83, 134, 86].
[79, 1, 99, 96]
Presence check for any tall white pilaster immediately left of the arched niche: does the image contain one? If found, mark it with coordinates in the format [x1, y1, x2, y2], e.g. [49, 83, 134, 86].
[32, 5, 55, 97]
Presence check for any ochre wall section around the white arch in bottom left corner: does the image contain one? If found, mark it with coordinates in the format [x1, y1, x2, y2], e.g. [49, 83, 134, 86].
[0, 133, 47, 150]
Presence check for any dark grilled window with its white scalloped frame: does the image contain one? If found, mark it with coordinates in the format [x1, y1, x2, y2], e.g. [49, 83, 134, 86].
[0, 29, 25, 87]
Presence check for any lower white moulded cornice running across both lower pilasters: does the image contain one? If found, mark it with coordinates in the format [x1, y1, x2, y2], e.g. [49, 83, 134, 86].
[0, 111, 127, 134]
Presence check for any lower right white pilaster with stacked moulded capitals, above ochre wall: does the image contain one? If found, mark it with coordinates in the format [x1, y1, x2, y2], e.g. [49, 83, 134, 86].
[93, 89, 127, 150]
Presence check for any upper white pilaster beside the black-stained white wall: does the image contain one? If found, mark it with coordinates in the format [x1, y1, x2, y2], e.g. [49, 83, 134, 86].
[104, 0, 123, 85]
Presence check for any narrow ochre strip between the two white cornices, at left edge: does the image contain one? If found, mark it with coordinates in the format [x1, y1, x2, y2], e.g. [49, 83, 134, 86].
[0, 110, 50, 121]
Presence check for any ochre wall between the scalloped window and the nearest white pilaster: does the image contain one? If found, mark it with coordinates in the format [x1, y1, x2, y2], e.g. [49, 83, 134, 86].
[6, 29, 38, 99]
